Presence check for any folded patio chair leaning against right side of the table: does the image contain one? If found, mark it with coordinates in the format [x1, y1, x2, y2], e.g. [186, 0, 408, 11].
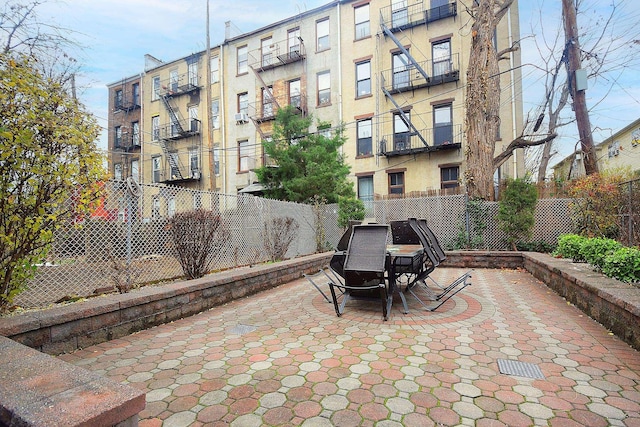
[406, 218, 471, 311]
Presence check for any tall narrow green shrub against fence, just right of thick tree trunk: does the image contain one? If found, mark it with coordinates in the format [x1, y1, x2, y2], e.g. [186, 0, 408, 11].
[497, 178, 538, 250]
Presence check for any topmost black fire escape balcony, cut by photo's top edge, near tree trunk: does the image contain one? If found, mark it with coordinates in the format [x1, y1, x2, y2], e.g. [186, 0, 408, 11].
[380, 1, 458, 33]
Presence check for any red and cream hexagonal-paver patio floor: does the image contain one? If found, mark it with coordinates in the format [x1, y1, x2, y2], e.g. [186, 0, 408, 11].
[60, 269, 640, 427]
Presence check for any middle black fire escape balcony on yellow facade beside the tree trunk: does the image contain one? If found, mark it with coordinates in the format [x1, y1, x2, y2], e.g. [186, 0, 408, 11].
[381, 53, 460, 93]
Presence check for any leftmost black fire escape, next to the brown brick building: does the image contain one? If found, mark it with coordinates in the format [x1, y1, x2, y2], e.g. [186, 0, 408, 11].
[158, 67, 201, 182]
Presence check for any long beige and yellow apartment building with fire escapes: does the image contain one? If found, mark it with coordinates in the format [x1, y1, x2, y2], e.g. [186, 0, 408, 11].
[106, 0, 524, 201]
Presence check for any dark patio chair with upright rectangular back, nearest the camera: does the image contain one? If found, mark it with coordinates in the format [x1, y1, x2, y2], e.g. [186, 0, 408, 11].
[329, 224, 392, 320]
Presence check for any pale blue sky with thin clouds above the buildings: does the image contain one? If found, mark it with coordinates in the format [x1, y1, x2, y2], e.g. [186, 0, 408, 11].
[37, 0, 640, 171]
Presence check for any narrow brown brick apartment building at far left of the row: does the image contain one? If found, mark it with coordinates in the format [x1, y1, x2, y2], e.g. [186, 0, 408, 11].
[107, 75, 142, 181]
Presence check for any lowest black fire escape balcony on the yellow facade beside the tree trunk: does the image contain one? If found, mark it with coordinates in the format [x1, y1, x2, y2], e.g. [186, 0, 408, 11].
[378, 125, 462, 157]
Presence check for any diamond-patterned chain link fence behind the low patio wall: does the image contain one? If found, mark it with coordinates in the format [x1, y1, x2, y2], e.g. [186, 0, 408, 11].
[15, 181, 573, 307]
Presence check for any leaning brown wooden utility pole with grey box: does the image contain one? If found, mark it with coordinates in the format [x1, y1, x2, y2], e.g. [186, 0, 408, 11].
[562, 0, 598, 175]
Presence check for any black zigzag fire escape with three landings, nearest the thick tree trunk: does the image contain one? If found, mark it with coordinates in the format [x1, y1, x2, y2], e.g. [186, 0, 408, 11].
[379, 2, 462, 157]
